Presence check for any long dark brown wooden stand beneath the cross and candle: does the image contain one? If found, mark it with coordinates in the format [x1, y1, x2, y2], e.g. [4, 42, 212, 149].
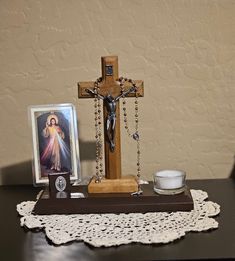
[33, 184, 193, 215]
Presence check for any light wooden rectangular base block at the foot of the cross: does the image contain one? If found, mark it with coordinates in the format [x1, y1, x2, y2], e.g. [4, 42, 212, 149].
[88, 176, 138, 193]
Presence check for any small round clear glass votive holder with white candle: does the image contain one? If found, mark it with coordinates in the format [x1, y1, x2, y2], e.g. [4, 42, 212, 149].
[153, 170, 186, 195]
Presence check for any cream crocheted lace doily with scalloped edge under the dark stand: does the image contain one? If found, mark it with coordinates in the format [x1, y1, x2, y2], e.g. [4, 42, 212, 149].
[17, 190, 220, 247]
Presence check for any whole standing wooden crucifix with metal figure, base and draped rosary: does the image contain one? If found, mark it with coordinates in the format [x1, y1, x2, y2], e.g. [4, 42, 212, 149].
[78, 56, 144, 193]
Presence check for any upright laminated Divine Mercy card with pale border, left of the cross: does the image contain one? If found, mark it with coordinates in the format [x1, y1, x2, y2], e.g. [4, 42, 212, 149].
[29, 104, 81, 186]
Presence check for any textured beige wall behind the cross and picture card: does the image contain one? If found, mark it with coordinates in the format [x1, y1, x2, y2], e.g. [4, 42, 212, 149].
[0, 0, 235, 184]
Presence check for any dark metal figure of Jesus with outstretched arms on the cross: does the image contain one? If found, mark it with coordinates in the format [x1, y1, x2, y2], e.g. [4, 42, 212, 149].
[86, 86, 137, 152]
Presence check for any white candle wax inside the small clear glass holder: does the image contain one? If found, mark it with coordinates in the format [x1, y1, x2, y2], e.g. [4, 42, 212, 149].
[154, 170, 185, 189]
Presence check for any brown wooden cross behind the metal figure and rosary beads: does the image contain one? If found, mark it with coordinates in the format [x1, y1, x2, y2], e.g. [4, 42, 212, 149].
[78, 56, 144, 193]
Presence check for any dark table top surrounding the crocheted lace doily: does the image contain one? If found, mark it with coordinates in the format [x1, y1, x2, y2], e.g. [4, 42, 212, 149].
[0, 179, 235, 261]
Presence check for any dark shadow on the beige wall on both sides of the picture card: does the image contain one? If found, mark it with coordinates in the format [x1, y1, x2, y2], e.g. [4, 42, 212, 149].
[0, 140, 96, 185]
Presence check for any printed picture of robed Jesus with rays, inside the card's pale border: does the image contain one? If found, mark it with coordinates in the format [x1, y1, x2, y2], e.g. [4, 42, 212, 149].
[37, 110, 72, 177]
